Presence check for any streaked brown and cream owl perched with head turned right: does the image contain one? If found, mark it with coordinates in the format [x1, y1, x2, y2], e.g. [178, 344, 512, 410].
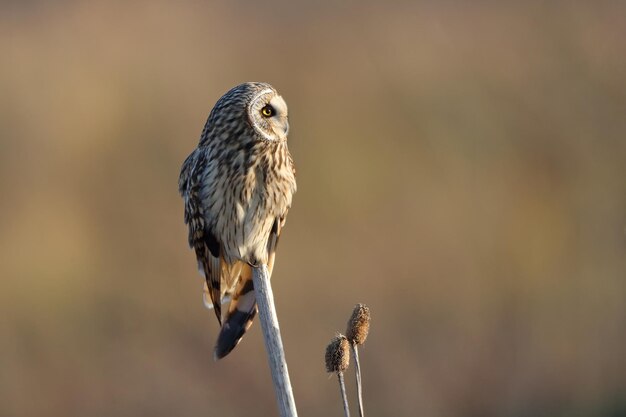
[178, 82, 296, 360]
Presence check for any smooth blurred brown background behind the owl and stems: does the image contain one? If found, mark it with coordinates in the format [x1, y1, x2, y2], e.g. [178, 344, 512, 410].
[0, 1, 626, 417]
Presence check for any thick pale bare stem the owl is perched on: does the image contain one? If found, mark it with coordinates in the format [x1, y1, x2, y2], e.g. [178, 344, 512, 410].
[252, 265, 298, 417]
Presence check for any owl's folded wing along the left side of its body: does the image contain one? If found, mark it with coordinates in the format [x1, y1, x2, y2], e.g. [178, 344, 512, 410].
[178, 149, 222, 324]
